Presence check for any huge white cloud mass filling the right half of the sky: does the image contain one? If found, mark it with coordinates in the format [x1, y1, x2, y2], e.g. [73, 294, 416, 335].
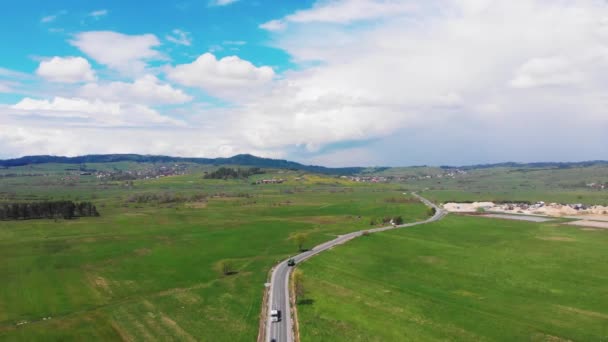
[239, 0, 608, 157]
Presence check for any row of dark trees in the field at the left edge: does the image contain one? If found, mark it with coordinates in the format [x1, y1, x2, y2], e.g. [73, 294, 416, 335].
[0, 201, 99, 220]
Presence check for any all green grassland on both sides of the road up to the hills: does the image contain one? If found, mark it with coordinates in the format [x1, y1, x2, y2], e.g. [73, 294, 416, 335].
[0, 162, 608, 341]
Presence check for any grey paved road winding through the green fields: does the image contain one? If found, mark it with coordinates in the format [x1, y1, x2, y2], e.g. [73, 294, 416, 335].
[265, 193, 446, 342]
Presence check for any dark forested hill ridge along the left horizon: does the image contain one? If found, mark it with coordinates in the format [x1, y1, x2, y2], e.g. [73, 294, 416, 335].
[0, 154, 363, 175]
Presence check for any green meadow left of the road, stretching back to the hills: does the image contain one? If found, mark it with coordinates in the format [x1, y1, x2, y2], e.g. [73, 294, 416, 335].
[0, 163, 427, 341]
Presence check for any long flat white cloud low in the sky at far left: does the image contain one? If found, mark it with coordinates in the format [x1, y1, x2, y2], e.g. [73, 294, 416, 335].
[9, 97, 182, 127]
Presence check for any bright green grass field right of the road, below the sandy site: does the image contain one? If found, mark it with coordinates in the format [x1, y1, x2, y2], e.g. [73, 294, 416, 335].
[298, 215, 608, 342]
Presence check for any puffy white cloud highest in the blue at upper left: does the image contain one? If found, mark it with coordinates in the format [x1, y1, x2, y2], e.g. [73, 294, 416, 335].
[70, 31, 165, 73]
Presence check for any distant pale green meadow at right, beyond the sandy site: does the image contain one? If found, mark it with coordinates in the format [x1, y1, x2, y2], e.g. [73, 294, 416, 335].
[394, 165, 608, 205]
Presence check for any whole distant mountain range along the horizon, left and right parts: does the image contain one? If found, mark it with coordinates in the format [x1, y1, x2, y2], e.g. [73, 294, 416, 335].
[0, 154, 608, 175]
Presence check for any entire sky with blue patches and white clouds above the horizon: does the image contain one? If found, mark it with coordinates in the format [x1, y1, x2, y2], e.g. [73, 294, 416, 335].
[0, 0, 608, 166]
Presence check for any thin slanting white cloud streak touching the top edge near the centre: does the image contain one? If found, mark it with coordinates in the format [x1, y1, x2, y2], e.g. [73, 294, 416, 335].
[260, 0, 415, 31]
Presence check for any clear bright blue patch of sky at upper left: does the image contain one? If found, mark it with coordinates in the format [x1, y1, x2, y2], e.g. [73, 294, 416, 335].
[0, 0, 304, 72]
